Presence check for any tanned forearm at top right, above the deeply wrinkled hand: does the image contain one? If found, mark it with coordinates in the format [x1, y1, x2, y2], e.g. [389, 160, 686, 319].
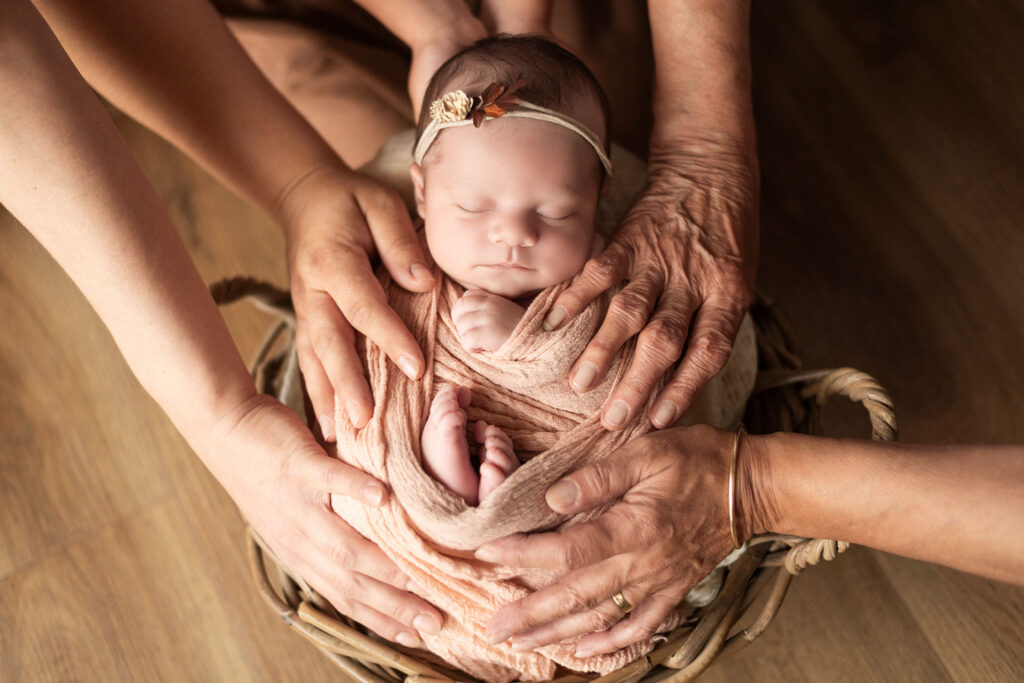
[648, 0, 754, 144]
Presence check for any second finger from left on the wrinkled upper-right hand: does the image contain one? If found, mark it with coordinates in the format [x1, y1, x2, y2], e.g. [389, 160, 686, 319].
[569, 270, 665, 392]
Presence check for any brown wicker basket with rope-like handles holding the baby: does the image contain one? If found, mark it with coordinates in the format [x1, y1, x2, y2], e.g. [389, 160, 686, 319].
[211, 279, 896, 683]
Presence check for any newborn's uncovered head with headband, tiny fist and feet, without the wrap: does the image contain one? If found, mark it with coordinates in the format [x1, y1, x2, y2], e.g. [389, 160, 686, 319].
[412, 38, 611, 505]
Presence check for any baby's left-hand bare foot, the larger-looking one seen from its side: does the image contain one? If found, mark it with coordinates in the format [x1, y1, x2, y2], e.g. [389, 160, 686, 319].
[420, 384, 480, 505]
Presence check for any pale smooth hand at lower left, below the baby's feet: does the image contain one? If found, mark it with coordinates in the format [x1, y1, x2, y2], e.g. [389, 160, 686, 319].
[203, 394, 441, 647]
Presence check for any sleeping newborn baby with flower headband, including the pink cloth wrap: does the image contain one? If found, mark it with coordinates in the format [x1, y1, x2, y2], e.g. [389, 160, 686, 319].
[331, 36, 756, 682]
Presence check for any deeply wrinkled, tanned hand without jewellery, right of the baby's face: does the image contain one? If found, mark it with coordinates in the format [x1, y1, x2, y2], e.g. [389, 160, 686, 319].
[545, 140, 758, 429]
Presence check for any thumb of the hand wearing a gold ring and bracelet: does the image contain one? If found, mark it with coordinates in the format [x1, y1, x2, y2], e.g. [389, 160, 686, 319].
[544, 449, 643, 514]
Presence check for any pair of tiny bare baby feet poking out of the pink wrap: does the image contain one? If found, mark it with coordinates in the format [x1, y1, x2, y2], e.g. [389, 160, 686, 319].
[420, 385, 519, 505]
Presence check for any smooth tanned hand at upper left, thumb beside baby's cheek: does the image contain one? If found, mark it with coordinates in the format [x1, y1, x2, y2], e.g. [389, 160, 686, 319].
[278, 164, 434, 440]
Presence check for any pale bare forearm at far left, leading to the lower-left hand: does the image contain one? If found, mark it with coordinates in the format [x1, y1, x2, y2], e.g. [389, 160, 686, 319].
[0, 0, 255, 444]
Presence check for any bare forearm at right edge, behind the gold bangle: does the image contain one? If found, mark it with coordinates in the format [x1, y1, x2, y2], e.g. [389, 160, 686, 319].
[741, 433, 1024, 583]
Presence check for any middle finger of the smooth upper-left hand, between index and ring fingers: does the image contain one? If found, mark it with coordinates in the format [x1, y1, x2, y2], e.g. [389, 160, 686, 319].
[304, 292, 374, 427]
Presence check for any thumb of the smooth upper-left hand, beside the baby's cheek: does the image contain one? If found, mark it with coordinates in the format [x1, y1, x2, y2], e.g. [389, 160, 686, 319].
[356, 186, 434, 292]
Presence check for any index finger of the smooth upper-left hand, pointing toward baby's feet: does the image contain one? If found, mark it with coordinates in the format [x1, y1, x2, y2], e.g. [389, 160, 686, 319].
[328, 251, 424, 380]
